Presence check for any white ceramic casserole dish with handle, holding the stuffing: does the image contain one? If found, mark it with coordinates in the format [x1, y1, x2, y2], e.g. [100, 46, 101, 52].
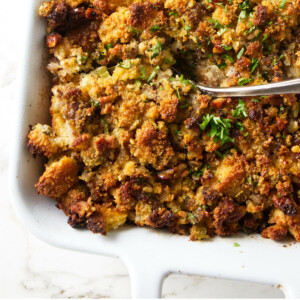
[10, 0, 300, 298]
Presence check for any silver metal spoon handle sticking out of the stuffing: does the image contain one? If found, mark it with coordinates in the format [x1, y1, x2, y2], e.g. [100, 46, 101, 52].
[197, 78, 300, 97]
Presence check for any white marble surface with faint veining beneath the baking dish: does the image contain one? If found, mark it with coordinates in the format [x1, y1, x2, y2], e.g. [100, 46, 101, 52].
[0, 0, 283, 298]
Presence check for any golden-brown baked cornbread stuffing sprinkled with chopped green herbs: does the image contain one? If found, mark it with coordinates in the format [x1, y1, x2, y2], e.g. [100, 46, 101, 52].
[28, 0, 300, 241]
